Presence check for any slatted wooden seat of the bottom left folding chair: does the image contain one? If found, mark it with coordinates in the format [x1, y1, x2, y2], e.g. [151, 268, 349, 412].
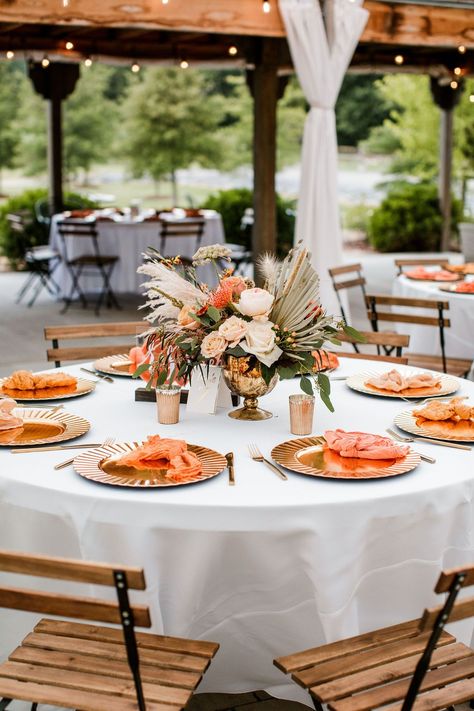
[0, 619, 218, 711]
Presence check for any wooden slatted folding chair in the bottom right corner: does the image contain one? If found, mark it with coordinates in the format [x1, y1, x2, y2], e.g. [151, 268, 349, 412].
[274, 566, 474, 711]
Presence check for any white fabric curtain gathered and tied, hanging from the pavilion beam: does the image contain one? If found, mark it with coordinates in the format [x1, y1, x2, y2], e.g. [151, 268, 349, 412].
[279, 0, 369, 314]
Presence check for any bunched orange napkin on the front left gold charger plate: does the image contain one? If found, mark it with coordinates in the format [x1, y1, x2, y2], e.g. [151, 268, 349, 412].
[116, 435, 202, 481]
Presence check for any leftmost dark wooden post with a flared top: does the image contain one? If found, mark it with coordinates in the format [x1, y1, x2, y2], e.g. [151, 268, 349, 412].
[29, 62, 79, 214]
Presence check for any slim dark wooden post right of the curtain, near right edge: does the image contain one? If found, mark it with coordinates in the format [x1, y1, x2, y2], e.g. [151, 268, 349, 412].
[430, 77, 464, 252]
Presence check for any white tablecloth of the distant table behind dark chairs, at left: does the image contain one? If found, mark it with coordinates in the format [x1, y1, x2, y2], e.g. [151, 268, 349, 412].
[49, 210, 225, 295]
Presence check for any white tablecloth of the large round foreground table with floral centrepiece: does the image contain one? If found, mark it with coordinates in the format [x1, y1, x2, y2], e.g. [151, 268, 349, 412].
[0, 359, 474, 702]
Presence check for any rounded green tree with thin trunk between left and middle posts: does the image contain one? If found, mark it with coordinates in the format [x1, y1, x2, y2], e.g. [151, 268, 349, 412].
[123, 68, 226, 204]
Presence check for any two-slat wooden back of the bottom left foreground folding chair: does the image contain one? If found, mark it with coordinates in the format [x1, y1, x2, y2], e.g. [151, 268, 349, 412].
[0, 551, 151, 627]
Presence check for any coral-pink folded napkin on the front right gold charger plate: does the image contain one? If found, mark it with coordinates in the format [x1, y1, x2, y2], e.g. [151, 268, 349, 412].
[324, 430, 410, 459]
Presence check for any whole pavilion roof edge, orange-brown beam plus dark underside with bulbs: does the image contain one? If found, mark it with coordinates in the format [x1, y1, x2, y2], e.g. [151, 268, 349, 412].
[0, 0, 474, 75]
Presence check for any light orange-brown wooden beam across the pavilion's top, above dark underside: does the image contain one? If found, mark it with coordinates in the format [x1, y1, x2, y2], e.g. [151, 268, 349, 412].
[0, 0, 474, 47]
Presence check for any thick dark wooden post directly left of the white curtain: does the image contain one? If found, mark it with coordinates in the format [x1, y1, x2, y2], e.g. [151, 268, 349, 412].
[248, 39, 279, 270]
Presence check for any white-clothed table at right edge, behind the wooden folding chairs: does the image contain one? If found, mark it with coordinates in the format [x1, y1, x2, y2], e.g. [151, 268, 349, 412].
[392, 275, 474, 360]
